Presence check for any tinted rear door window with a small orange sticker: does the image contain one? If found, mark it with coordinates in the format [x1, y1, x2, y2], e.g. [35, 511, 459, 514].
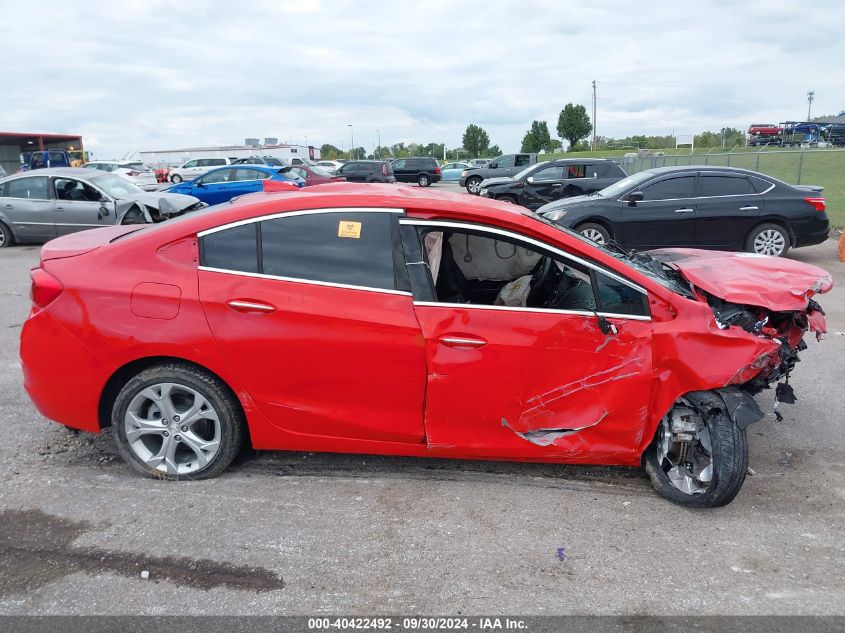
[261, 212, 396, 290]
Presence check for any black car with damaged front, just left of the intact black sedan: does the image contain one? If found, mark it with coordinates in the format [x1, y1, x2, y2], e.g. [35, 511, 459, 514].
[478, 158, 625, 209]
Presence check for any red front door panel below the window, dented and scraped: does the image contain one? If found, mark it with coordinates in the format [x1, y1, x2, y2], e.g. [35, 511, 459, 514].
[416, 303, 652, 463]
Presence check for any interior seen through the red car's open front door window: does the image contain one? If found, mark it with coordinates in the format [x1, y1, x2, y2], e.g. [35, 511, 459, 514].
[420, 230, 596, 311]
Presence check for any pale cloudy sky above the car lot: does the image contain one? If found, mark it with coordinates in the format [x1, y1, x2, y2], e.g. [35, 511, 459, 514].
[0, 0, 845, 158]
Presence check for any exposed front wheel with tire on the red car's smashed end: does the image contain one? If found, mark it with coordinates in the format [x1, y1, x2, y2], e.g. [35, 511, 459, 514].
[644, 404, 748, 508]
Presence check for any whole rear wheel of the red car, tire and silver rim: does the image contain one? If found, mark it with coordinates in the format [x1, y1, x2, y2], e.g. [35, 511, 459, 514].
[112, 363, 246, 479]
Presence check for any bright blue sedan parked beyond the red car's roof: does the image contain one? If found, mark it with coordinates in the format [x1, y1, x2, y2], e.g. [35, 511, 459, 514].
[167, 165, 305, 205]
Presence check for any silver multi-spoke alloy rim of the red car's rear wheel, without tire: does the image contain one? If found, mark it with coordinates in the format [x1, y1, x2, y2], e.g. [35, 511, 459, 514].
[123, 382, 221, 475]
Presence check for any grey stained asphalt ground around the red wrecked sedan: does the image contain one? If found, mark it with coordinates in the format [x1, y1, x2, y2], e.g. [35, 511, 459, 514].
[0, 214, 845, 615]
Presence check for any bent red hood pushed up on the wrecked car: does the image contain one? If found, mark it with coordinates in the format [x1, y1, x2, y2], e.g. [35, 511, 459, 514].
[649, 248, 833, 312]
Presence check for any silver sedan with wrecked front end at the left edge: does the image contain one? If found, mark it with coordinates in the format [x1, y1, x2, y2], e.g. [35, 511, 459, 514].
[0, 167, 207, 248]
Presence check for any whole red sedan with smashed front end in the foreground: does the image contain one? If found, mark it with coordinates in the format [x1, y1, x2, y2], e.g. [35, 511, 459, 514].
[21, 184, 832, 506]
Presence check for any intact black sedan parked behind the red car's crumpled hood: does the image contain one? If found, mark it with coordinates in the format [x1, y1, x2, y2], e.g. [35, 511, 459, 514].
[537, 165, 830, 256]
